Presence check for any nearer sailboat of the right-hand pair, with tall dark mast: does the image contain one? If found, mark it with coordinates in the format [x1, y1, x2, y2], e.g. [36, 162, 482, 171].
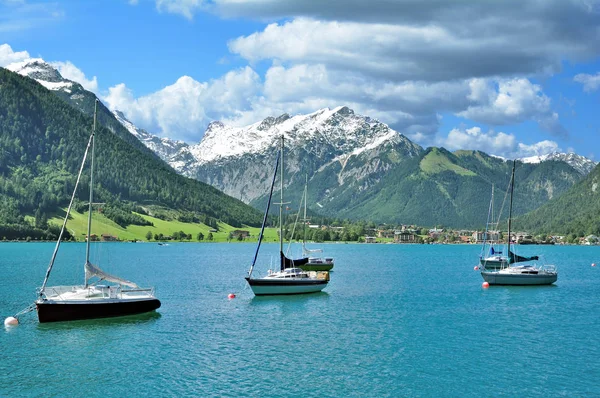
[481, 160, 558, 285]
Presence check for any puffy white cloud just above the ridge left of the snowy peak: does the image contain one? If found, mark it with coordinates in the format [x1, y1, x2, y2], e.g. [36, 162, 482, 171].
[103, 67, 260, 141]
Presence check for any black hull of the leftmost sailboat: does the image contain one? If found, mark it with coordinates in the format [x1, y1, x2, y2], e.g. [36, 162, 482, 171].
[36, 298, 160, 323]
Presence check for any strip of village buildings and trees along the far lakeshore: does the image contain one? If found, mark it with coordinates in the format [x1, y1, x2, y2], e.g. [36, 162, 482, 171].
[16, 224, 600, 245]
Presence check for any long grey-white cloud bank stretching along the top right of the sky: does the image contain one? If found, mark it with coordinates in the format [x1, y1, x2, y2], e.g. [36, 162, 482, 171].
[225, 0, 600, 80]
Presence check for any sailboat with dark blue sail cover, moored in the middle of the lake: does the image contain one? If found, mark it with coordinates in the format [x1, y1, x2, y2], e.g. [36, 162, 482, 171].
[246, 135, 329, 296]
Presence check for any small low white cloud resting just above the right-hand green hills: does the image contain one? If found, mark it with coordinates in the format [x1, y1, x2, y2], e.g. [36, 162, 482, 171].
[438, 127, 560, 159]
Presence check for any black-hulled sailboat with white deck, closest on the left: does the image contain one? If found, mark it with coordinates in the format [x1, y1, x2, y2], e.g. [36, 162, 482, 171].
[35, 100, 160, 322]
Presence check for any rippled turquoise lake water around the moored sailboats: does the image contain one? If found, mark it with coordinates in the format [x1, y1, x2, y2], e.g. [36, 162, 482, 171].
[0, 243, 600, 397]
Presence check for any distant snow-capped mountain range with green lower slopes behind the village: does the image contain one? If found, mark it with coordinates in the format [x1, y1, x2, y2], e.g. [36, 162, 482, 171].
[4, 60, 596, 232]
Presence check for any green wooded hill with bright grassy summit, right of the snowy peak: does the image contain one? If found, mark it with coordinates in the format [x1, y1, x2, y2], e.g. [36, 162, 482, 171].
[336, 148, 581, 228]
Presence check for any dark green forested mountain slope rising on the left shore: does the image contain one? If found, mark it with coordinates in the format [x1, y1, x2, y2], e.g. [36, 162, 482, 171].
[0, 68, 261, 239]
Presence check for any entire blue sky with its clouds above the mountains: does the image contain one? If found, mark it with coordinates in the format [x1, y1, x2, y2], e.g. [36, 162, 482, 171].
[0, 0, 600, 161]
